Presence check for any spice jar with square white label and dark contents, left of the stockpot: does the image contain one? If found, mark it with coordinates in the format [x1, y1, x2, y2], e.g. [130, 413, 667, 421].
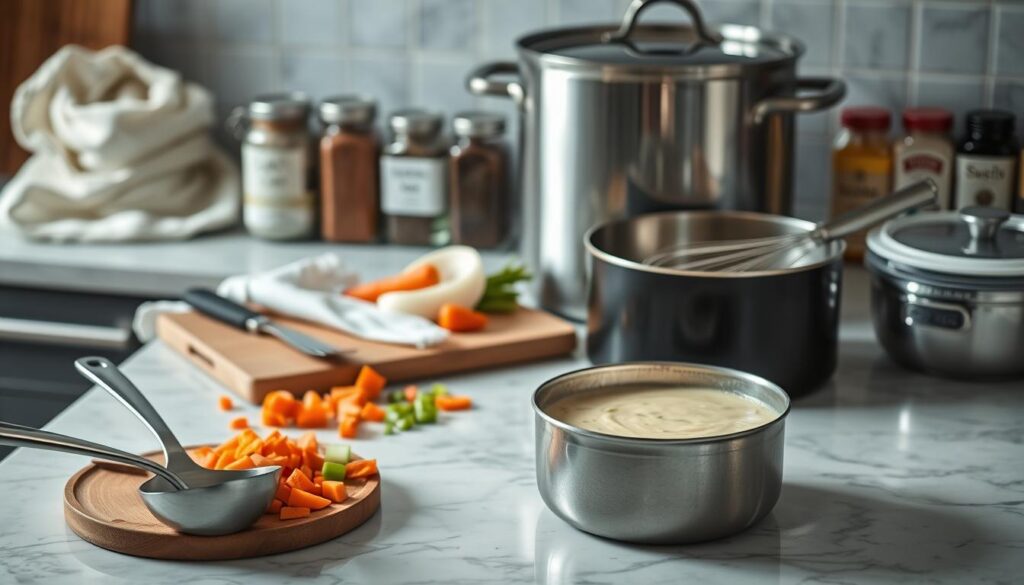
[380, 110, 449, 246]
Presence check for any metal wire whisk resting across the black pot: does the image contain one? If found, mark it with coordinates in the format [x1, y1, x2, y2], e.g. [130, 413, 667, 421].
[643, 179, 938, 273]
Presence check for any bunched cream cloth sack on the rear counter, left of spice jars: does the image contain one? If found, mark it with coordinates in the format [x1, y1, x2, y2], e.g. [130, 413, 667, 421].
[0, 45, 241, 242]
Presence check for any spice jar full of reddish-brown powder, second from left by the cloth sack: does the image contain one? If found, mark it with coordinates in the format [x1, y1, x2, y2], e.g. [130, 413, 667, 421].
[319, 95, 380, 242]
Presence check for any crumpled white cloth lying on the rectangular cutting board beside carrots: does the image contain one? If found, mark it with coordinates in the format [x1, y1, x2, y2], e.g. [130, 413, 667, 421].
[133, 253, 449, 347]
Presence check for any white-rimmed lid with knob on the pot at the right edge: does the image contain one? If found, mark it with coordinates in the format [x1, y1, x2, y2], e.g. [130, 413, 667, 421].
[867, 207, 1024, 279]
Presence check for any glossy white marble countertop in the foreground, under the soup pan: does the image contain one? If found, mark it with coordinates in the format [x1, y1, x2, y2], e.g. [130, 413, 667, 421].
[0, 270, 1024, 585]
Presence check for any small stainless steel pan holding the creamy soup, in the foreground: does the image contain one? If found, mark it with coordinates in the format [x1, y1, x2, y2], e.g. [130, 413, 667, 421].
[534, 363, 790, 543]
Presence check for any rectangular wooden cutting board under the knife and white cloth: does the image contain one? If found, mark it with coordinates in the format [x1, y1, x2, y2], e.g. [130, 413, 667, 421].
[157, 308, 577, 404]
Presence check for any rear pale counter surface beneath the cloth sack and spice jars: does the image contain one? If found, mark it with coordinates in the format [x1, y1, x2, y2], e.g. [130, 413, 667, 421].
[0, 229, 511, 298]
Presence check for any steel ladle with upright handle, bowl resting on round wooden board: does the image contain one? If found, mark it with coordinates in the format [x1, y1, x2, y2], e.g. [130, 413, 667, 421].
[75, 358, 281, 536]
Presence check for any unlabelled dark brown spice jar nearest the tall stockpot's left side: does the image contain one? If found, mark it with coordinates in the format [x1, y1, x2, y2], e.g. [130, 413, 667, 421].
[450, 112, 510, 248]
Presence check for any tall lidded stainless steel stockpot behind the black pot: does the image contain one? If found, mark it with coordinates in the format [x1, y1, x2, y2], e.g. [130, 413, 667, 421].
[467, 0, 845, 320]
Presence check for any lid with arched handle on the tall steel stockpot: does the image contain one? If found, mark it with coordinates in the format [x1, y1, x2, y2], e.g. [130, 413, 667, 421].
[517, 0, 804, 78]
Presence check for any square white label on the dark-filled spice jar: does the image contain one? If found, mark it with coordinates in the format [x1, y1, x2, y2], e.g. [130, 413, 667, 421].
[381, 157, 447, 217]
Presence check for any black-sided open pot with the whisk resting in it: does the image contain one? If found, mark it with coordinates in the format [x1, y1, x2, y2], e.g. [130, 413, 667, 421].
[585, 211, 845, 395]
